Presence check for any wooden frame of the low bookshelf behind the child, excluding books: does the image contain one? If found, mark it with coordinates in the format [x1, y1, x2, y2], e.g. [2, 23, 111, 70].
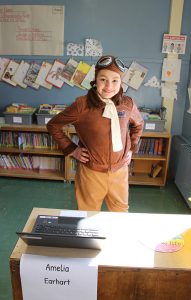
[0, 124, 171, 186]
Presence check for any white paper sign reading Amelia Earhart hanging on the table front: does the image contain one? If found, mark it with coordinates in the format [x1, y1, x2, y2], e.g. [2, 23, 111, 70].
[20, 254, 98, 300]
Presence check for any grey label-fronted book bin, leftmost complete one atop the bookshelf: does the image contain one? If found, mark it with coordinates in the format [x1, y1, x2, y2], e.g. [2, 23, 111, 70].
[3, 112, 34, 125]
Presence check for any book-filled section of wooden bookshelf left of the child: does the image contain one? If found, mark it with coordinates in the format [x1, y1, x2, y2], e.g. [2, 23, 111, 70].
[0, 125, 66, 180]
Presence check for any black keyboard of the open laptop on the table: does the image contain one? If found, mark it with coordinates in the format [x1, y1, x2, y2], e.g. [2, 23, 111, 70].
[33, 224, 99, 237]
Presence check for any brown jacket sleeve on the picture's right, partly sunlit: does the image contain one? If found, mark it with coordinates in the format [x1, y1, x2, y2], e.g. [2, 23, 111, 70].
[129, 101, 144, 152]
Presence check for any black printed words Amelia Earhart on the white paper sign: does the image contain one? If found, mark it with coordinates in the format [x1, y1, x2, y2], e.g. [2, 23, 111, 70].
[44, 264, 71, 286]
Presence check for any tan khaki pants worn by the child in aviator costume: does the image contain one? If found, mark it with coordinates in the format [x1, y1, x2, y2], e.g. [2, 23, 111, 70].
[75, 163, 129, 212]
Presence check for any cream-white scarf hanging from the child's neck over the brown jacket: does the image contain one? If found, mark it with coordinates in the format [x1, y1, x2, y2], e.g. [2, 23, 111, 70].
[99, 95, 123, 152]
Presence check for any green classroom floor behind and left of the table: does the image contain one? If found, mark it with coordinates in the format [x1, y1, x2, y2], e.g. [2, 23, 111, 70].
[0, 178, 191, 300]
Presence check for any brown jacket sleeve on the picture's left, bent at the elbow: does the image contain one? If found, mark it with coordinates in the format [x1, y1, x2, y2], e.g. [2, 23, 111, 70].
[46, 101, 78, 155]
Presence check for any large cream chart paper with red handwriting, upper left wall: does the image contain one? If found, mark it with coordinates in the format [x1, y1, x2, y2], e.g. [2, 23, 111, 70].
[0, 5, 64, 56]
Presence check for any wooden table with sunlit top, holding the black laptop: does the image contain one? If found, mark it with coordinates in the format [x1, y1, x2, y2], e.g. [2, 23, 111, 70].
[10, 208, 191, 300]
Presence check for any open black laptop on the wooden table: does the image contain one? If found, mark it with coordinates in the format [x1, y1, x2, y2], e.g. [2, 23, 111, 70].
[16, 215, 106, 250]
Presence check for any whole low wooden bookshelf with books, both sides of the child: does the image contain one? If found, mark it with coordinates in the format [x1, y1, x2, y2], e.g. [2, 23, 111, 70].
[0, 125, 171, 187]
